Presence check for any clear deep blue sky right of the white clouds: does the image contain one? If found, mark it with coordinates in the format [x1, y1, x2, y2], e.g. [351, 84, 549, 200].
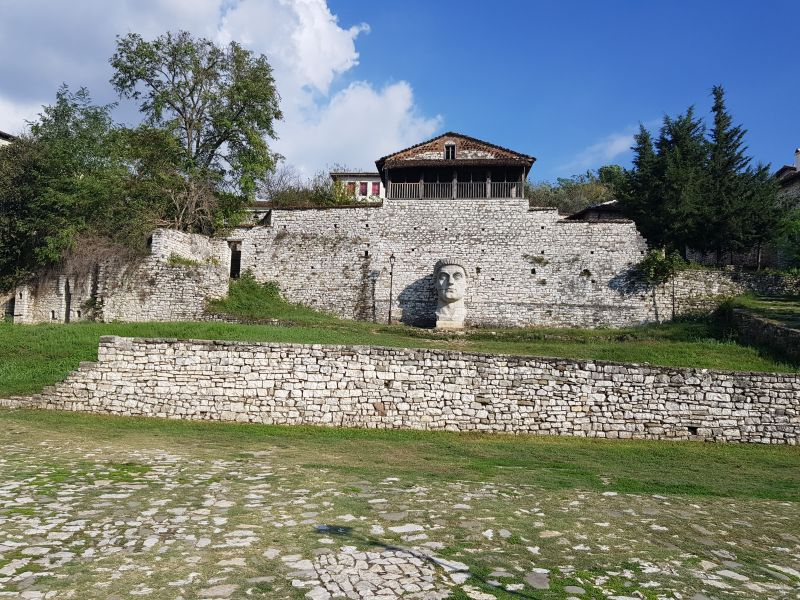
[329, 0, 800, 179]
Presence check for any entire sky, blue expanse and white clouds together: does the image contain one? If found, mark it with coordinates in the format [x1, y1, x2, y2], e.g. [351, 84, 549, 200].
[0, 0, 800, 181]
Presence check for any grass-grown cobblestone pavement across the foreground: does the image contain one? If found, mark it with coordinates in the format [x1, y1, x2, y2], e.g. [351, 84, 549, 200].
[0, 424, 800, 600]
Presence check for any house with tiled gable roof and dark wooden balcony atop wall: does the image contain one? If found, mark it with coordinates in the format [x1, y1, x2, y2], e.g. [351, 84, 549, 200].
[375, 131, 536, 199]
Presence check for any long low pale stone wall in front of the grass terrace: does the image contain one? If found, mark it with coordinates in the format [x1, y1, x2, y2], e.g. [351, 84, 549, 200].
[25, 337, 800, 444]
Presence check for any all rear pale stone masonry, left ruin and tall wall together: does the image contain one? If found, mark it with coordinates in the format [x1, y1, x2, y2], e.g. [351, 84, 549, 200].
[10, 198, 800, 327]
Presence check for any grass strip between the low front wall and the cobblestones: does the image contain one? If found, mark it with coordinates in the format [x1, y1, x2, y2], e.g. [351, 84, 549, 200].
[6, 410, 800, 501]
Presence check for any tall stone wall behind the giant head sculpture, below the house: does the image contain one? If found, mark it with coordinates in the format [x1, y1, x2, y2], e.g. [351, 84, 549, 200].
[235, 199, 792, 327]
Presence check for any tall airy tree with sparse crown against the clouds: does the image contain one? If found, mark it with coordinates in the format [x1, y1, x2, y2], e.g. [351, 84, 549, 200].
[110, 31, 282, 203]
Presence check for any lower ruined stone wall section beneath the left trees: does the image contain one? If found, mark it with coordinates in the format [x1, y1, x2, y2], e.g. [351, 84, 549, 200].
[14, 229, 230, 324]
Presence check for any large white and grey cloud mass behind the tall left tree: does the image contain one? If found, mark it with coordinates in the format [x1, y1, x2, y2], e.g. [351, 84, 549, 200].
[0, 0, 441, 174]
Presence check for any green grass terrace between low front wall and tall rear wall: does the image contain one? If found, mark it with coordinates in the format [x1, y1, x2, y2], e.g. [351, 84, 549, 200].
[0, 278, 798, 397]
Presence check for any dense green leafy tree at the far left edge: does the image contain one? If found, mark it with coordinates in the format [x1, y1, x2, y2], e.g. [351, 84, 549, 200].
[0, 86, 125, 289]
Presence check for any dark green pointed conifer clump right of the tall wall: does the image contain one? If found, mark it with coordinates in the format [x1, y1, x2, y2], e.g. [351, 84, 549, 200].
[620, 86, 781, 262]
